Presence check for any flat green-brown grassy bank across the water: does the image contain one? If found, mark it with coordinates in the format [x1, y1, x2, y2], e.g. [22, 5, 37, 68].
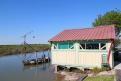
[0, 44, 50, 55]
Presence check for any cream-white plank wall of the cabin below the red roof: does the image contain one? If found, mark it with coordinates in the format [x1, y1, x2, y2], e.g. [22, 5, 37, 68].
[51, 43, 113, 68]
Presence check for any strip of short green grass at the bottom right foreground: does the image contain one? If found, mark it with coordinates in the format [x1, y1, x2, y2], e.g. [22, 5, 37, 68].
[84, 76, 114, 81]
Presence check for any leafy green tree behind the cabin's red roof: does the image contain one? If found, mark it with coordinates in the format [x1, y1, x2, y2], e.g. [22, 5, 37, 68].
[92, 9, 121, 35]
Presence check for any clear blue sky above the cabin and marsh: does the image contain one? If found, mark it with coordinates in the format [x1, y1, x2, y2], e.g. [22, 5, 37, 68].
[0, 0, 121, 45]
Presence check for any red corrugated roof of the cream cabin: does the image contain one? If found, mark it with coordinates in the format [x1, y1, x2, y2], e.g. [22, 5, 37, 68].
[49, 25, 115, 42]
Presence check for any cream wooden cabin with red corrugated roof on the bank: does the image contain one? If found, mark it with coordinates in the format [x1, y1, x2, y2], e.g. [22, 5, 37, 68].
[49, 25, 115, 69]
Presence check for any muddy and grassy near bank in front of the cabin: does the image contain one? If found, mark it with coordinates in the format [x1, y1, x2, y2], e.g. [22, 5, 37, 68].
[54, 70, 114, 81]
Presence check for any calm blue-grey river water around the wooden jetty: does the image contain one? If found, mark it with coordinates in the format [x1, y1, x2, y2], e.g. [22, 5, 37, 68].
[0, 52, 55, 81]
